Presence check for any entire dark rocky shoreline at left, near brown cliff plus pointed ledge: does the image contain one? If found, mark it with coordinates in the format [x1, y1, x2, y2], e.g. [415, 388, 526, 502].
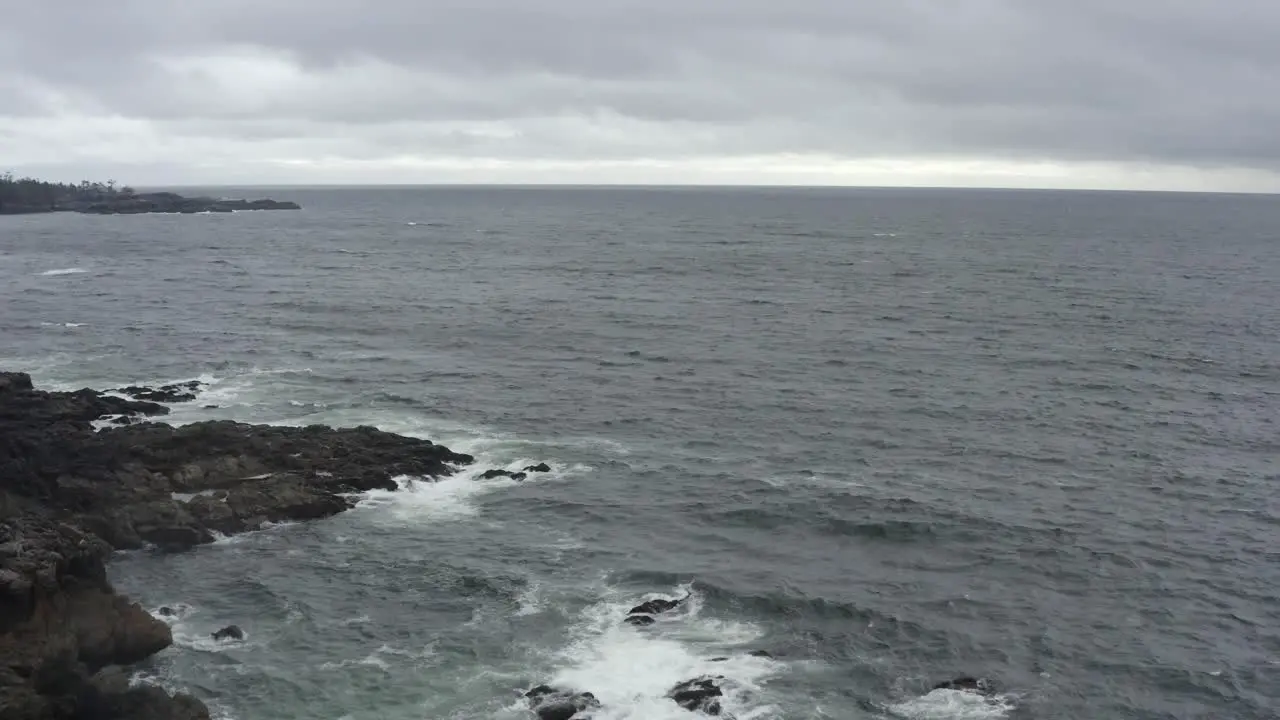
[0, 373, 474, 720]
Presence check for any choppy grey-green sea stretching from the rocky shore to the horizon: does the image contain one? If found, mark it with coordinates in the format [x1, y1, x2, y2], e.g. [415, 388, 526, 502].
[0, 188, 1280, 720]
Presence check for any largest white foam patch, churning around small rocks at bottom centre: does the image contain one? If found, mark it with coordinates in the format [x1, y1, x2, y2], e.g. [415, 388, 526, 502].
[549, 588, 778, 720]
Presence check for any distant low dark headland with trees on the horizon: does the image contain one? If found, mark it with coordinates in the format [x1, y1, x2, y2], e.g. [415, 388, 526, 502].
[0, 173, 302, 215]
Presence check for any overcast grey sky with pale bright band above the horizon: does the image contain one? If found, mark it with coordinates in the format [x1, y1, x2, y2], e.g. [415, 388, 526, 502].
[0, 0, 1280, 191]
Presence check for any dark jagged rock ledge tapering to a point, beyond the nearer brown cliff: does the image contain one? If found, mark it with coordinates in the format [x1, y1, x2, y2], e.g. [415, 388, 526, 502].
[0, 374, 472, 548]
